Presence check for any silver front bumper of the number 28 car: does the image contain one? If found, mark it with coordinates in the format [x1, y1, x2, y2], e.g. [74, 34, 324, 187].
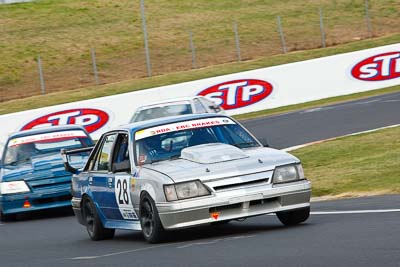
[157, 180, 311, 229]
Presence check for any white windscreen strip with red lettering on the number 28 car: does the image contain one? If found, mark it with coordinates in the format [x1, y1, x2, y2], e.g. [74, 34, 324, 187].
[135, 118, 235, 140]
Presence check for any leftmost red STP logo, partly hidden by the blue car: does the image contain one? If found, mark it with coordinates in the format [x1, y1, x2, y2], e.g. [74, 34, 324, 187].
[21, 108, 110, 133]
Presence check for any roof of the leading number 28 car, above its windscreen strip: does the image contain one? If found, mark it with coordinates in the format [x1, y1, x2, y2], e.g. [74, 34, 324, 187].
[114, 113, 230, 132]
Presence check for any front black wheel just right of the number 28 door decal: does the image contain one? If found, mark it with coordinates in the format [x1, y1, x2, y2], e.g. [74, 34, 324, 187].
[140, 193, 165, 243]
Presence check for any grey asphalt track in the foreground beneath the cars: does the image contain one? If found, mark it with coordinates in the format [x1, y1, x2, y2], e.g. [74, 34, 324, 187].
[0, 195, 400, 267]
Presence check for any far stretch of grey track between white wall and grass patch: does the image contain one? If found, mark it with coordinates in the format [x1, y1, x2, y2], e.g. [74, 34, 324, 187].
[243, 92, 400, 149]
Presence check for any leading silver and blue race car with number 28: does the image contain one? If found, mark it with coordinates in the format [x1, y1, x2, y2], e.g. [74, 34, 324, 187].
[64, 114, 311, 242]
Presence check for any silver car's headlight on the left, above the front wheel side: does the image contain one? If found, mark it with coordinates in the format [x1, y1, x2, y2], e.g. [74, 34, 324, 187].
[164, 181, 211, 201]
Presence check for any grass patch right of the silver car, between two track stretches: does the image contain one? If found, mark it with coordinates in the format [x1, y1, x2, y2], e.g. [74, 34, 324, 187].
[291, 127, 400, 198]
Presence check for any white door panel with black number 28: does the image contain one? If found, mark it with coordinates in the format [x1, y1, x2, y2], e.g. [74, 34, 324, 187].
[114, 175, 138, 220]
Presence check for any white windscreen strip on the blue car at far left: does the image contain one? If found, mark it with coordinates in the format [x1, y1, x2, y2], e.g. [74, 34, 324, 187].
[8, 130, 87, 147]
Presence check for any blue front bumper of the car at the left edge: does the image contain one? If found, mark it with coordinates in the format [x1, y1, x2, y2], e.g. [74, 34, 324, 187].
[0, 190, 71, 214]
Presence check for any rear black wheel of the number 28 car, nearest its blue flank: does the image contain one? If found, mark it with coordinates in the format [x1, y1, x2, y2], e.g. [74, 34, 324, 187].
[82, 197, 115, 241]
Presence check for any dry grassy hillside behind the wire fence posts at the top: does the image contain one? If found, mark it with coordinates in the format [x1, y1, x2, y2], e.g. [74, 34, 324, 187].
[0, 0, 400, 101]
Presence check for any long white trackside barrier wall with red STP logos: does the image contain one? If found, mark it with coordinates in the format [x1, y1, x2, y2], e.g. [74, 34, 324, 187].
[0, 43, 400, 142]
